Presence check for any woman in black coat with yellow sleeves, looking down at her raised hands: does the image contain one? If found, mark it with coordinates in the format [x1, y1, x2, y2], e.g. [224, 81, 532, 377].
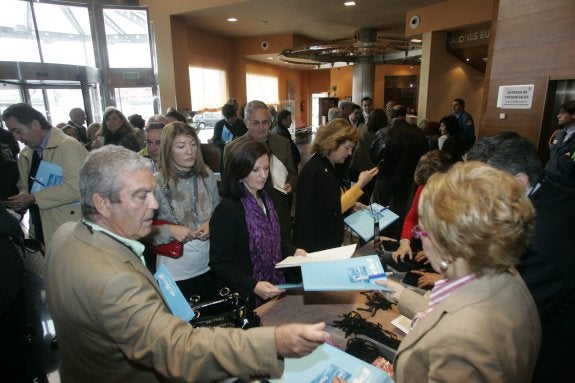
[294, 118, 377, 251]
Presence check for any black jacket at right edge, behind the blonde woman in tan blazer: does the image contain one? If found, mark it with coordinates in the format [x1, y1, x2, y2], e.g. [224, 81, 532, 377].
[517, 182, 575, 382]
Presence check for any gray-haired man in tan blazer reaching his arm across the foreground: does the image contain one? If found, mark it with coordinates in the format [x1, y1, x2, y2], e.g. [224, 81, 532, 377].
[45, 145, 329, 383]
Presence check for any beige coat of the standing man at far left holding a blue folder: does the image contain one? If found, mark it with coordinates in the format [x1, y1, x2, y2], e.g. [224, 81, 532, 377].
[18, 128, 88, 245]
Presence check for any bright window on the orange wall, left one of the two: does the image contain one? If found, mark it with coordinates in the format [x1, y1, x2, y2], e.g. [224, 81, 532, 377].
[189, 67, 228, 111]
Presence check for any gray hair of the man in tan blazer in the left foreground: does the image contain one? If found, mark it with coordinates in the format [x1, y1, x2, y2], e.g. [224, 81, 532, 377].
[80, 145, 151, 218]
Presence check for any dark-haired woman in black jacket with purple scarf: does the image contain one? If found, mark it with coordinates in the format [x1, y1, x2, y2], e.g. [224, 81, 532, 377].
[210, 140, 285, 305]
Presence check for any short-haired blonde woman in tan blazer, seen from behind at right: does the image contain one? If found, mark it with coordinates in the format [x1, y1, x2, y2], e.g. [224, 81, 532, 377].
[348, 162, 541, 383]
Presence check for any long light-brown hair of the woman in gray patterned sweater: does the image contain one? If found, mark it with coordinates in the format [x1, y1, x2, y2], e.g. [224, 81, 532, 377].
[158, 121, 209, 185]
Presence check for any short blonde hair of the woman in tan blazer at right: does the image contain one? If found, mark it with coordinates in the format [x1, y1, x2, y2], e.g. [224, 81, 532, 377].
[418, 162, 535, 276]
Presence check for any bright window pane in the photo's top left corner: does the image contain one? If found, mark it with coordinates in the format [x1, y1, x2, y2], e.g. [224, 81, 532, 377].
[0, 0, 40, 62]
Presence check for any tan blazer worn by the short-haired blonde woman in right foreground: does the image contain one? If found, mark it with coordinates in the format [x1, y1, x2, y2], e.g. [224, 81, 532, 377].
[394, 273, 541, 383]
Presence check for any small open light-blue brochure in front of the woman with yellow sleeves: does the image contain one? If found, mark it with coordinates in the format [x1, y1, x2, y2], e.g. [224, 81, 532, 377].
[343, 203, 399, 242]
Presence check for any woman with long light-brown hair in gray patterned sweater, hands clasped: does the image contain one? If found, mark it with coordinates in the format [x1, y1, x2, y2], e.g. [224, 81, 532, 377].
[153, 121, 224, 301]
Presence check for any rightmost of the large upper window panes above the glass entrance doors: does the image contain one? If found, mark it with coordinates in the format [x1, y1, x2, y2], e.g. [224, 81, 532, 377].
[104, 9, 152, 68]
